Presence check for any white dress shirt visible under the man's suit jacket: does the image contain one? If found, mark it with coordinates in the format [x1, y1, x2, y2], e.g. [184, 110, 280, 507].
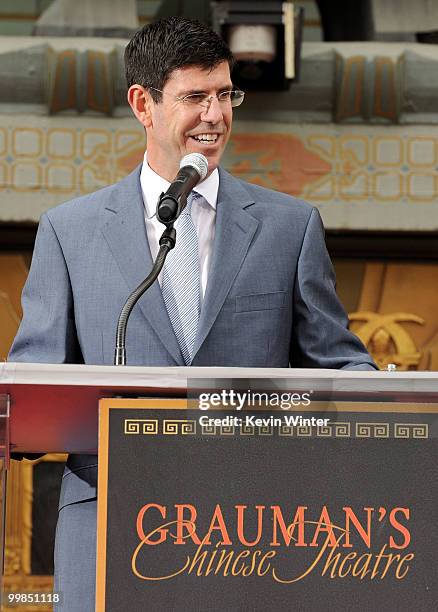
[140, 152, 219, 299]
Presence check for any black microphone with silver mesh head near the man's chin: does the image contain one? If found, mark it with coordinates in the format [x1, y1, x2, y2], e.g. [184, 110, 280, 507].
[157, 153, 208, 225]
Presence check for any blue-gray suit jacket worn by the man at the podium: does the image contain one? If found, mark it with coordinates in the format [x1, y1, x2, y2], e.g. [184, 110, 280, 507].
[9, 161, 375, 506]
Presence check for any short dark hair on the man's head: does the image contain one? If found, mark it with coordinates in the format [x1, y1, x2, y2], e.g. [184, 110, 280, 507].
[125, 17, 234, 102]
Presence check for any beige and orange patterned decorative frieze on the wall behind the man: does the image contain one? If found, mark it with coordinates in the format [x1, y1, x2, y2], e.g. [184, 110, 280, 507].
[0, 114, 438, 230]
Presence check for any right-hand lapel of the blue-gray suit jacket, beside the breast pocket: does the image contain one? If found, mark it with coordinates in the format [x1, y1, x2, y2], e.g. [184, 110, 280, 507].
[194, 169, 259, 355]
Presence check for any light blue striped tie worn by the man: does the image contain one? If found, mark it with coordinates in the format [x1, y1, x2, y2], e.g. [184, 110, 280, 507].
[161, 191, 202, 365]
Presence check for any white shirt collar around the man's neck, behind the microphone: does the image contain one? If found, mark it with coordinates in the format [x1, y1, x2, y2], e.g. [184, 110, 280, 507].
[140, 151, 219, 219]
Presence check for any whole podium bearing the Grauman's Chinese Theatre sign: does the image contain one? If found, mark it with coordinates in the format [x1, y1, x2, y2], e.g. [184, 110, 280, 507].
[0, 363, 438, 612]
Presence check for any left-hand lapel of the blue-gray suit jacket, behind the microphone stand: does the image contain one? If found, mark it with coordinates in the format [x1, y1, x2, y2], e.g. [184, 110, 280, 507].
[102, 166, 185, 365]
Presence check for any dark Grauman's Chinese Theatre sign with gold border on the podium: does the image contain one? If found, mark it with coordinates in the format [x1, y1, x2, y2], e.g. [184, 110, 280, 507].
[96, 399, 438, 612]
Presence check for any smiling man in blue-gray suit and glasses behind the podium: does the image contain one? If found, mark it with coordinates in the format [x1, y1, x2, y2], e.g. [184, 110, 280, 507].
[10, 18, 375, 612]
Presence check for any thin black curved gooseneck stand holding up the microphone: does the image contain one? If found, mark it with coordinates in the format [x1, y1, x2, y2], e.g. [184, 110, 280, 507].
[114, 223, 176, 365]
